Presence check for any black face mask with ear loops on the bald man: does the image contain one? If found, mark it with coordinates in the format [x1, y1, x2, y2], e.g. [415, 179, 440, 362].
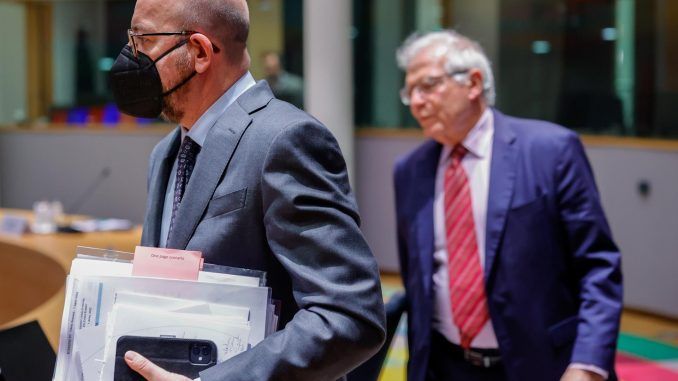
[109, 40, 197, 118]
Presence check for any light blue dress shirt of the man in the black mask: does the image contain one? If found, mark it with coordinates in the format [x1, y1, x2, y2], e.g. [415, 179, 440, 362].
[160, 72, 256, 247]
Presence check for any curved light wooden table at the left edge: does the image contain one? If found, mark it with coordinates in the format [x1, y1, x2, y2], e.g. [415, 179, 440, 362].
[0, 209, 141, 349]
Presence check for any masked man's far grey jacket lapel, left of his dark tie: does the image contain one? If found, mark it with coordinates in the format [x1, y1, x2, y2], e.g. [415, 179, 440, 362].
[141, 127, 181, 247]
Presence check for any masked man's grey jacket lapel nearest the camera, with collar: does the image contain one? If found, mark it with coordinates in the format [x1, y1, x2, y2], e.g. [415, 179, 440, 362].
[167, 82, 273, 249]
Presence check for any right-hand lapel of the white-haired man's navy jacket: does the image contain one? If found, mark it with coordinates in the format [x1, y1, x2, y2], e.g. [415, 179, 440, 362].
[485, 110, 518, 280]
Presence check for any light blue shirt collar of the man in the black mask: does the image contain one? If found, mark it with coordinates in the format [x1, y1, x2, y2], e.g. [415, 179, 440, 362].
[181, 71, 256, 147]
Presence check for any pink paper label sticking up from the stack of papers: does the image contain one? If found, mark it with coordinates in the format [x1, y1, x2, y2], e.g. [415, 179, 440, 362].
[132, 246, 203, 280]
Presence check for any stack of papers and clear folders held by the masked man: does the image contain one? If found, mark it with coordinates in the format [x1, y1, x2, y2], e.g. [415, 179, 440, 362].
[54, 248, 277, 381]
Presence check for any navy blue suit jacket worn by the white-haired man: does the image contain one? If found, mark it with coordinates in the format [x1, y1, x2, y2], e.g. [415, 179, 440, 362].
[394, 110, 622, 381]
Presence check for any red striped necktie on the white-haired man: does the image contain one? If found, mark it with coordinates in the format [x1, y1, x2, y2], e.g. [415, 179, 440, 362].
[445, 145, 489, 348]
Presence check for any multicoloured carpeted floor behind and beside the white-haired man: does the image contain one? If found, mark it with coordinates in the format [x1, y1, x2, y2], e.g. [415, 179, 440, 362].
[379, 280, 678, 381]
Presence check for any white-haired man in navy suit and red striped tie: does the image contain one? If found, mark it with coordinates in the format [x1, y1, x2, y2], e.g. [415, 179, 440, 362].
[394, 31, 622, 381]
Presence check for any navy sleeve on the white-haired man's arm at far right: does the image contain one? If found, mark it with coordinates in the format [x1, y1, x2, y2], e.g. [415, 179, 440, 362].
[557, 134, 622, 371]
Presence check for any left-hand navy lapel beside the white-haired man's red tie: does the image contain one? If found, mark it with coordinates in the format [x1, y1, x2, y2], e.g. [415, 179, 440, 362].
[414, 141, 442, 295]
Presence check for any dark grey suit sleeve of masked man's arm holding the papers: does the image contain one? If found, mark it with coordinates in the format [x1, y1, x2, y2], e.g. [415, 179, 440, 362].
[201, 121, 385, 381]
